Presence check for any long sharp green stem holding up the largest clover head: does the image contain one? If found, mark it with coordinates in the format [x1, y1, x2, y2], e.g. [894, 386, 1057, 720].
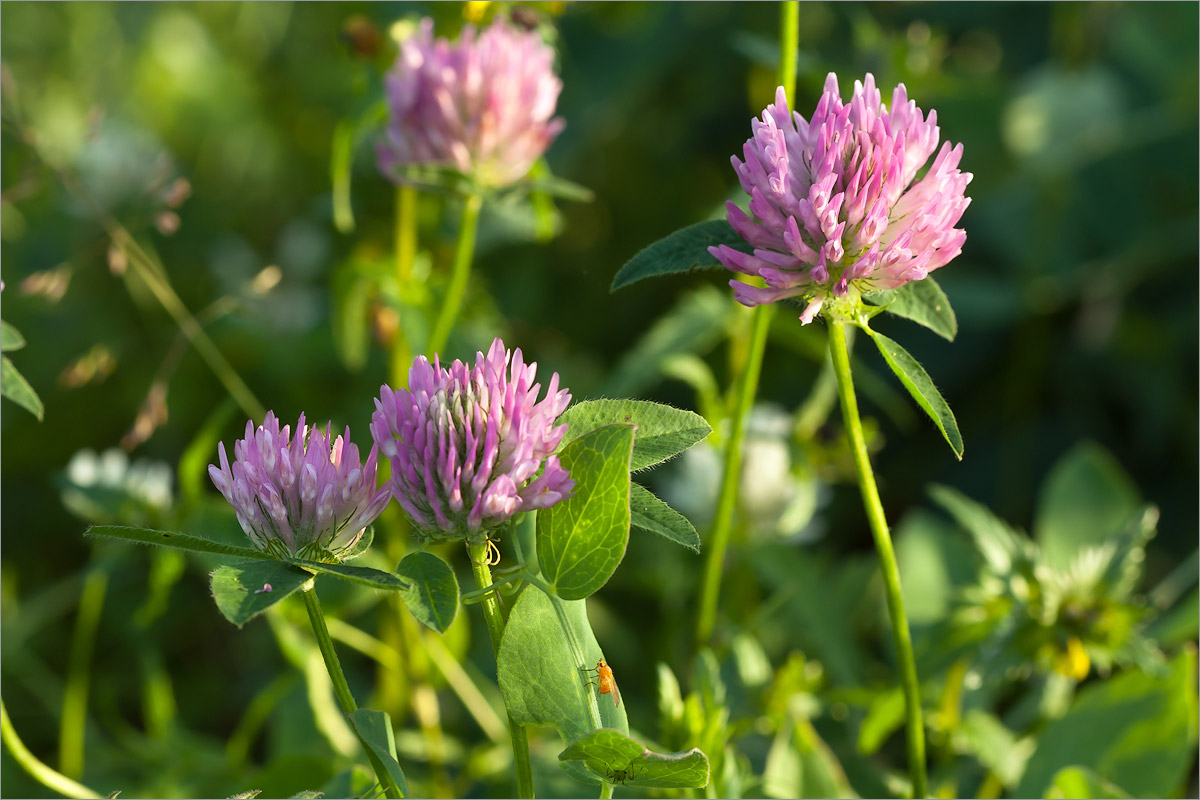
[829, 319, 925, 798]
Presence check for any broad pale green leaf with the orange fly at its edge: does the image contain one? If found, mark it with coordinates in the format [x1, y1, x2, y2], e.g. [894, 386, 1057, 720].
[496, 587, 629, 781]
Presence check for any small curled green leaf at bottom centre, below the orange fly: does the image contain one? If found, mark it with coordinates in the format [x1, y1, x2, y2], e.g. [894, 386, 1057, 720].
[558, 728, 708, 789]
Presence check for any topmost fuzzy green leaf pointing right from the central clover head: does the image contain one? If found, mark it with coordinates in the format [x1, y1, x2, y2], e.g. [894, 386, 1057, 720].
[558, 399, 713, 473]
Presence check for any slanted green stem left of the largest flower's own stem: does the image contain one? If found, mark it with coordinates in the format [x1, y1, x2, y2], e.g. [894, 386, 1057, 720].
[696, 299, 773, 645]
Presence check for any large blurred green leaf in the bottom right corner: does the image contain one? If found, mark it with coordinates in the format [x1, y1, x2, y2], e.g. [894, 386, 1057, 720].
[1013, 650, 1196, 798]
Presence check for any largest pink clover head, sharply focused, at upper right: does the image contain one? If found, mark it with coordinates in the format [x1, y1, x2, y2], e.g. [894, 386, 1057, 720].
[709, 73, 971, 324]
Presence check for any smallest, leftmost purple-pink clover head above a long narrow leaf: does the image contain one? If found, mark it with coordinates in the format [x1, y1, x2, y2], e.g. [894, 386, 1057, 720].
[209, 411, 391, 561]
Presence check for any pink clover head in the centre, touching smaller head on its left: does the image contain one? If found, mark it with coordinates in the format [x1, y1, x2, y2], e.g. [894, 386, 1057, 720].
[371, 339, 575, 541]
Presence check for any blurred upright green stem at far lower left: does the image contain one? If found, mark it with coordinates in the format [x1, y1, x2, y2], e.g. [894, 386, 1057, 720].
[59, 570, 108, 777]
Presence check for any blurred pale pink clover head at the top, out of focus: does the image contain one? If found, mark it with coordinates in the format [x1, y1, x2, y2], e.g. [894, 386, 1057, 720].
[377, 18, 564, 188]
